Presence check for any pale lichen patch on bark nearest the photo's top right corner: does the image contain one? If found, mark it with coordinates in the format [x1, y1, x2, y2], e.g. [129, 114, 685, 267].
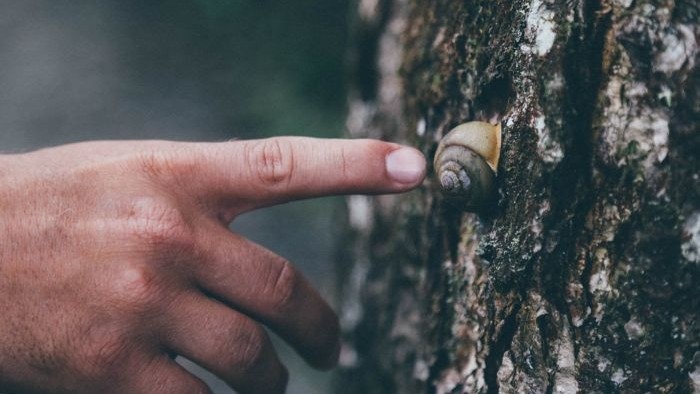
[654, 24, 698, 74]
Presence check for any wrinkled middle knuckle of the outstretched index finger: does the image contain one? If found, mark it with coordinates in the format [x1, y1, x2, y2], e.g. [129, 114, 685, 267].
[246, 138, 294, 186]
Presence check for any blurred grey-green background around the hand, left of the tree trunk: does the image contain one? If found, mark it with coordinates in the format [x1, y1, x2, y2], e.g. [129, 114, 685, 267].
[0, 0, 350, 394]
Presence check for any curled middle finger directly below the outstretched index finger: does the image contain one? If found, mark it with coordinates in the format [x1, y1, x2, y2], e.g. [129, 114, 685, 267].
[193, 221, 340, 369]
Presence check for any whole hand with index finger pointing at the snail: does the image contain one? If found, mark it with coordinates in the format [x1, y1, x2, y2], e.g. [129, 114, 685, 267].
[0, 137, 425, 394]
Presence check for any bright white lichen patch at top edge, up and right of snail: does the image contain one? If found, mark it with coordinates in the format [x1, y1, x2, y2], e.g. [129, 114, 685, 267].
[521, 0, 557, 56]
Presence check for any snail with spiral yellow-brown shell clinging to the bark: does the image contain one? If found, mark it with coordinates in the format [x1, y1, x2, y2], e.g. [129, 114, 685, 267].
[433, 122, 501, 212]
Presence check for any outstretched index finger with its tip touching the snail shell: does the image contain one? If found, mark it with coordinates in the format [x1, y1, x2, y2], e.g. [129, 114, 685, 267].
[187, 137, 426, 212]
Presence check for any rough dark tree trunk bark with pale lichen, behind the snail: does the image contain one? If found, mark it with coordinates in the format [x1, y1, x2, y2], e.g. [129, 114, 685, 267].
[338, 0, 700, 393]
